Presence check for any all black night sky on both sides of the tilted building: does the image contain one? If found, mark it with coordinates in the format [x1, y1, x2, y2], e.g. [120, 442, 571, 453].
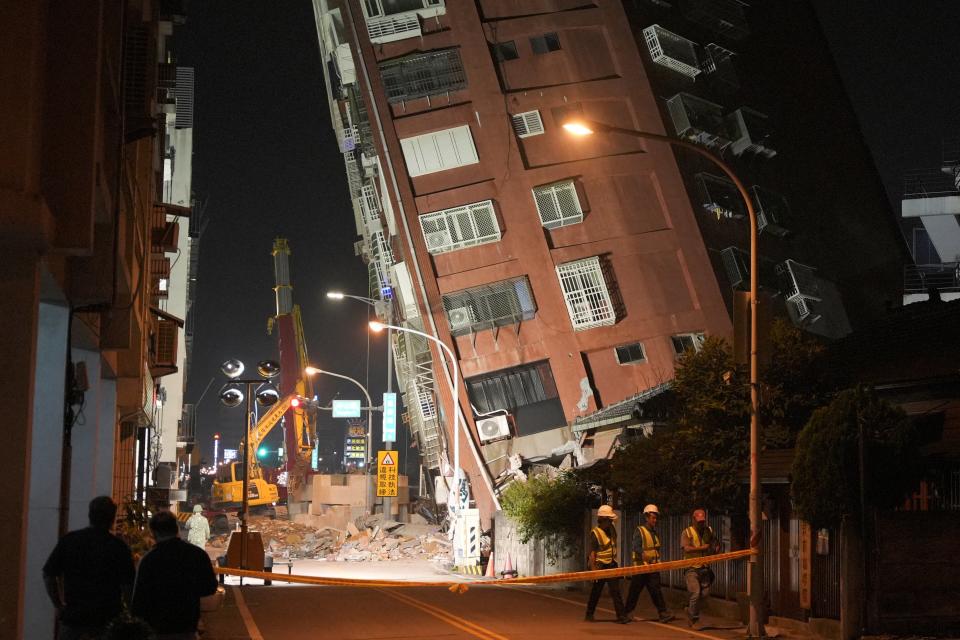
[174, 0, 960, 468]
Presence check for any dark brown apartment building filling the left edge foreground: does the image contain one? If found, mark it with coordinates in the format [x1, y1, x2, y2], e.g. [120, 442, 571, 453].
[0, 0, 192, 638]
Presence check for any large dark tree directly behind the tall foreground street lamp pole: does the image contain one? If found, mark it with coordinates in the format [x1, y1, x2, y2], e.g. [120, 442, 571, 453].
[610, 319, 832, 511]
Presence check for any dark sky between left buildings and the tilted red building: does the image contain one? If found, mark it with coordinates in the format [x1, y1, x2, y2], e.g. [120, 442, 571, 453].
[175, 0, 386, 468]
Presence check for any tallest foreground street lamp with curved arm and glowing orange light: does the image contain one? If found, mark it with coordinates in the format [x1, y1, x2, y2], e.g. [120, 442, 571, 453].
[561, 115, 766, 638]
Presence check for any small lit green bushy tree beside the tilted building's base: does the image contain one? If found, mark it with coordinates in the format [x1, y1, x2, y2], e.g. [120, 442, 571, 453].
[500, 472, 590, 564]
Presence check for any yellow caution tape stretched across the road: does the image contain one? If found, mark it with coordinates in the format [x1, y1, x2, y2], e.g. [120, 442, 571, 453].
[215, 549, 758, 594]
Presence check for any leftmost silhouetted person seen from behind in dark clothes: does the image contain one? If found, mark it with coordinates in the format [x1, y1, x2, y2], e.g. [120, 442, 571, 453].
[43, 496, 134, 640]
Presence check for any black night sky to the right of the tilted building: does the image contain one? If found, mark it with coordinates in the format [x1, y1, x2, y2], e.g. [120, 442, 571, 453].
[808, 0, 960, 214]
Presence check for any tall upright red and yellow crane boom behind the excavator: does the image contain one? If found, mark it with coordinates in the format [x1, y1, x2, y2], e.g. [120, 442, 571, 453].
[267, 238, 316, 500]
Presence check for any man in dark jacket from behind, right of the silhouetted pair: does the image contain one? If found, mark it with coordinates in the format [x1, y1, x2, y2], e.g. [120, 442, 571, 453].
[132, 511, 217, 640]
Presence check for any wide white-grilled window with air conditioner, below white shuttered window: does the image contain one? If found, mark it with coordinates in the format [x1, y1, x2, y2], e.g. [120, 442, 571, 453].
[420, 200, 500, 255]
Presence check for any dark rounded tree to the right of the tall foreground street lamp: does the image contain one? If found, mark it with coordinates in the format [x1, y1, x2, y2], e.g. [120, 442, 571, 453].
[792, 387, 917, 527]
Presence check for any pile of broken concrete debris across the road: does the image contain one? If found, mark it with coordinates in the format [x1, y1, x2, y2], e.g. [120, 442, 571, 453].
[209, 514, 452, 562]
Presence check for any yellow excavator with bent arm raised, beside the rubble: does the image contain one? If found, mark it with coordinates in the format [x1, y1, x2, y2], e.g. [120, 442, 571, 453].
[211, 393, 309, 516]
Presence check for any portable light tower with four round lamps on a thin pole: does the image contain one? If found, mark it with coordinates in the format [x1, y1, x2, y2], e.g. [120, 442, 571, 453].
[220, 358, 280, 570]
